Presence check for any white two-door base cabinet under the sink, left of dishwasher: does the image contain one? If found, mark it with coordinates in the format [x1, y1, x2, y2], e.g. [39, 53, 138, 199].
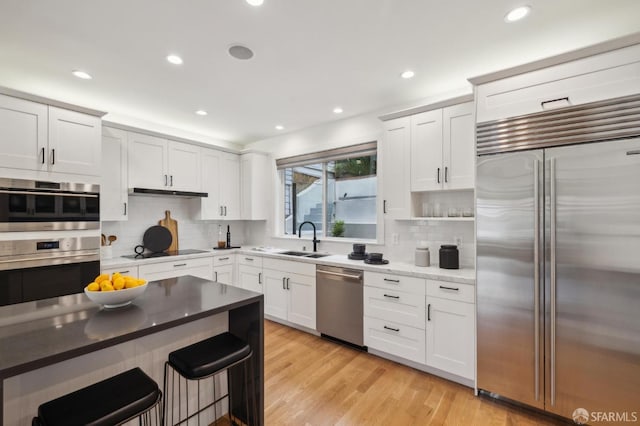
[263, 259, 316, 330]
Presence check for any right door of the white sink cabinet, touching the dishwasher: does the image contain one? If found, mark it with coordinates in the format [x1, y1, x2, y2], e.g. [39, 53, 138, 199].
[285, 274, 316, 330]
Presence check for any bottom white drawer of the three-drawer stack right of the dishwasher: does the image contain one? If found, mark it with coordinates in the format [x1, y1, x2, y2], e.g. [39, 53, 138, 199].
[364, 316, 426, 364]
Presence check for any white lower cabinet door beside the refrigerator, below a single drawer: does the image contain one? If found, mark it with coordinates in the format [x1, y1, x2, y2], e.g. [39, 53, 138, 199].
[427, 297, 475, 379]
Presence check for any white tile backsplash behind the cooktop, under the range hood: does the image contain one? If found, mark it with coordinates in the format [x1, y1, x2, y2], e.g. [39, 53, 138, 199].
[102, 196, 245, 256]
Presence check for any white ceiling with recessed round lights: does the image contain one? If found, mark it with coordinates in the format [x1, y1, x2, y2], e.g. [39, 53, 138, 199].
[0, 0, 640, 144]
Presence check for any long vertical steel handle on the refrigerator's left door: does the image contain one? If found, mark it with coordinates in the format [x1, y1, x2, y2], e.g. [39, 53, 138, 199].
[533, 160, 540, 401]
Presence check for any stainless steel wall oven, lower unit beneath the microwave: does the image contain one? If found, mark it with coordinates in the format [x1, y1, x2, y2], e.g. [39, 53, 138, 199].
[0, 236, 100, 306]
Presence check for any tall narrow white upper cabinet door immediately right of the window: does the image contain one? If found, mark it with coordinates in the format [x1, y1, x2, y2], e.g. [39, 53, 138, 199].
[381, 117, 411, 219]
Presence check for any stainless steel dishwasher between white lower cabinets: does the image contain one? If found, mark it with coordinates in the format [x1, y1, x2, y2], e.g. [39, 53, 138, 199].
[316, 265, 364, 347]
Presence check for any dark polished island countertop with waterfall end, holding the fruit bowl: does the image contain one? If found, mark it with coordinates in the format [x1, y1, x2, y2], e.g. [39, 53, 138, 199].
[0, 276, 264, 425]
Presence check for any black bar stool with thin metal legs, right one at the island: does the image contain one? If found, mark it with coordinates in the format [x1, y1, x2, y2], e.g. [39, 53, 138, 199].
[162, 332, 258, 425]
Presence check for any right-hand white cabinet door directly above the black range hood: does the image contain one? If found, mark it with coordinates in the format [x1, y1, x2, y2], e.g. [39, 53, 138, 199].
[168, 141, 202, 192]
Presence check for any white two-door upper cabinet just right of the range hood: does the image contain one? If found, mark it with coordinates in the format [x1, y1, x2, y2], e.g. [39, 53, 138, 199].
[200, 148, 240, 220]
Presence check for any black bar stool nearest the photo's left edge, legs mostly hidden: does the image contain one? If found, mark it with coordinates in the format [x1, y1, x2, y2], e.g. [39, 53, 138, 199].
[31, 368, 162, 426]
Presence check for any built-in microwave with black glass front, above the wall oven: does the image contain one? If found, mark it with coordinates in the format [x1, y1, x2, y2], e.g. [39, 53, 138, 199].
[0, 178, 100, 232]
